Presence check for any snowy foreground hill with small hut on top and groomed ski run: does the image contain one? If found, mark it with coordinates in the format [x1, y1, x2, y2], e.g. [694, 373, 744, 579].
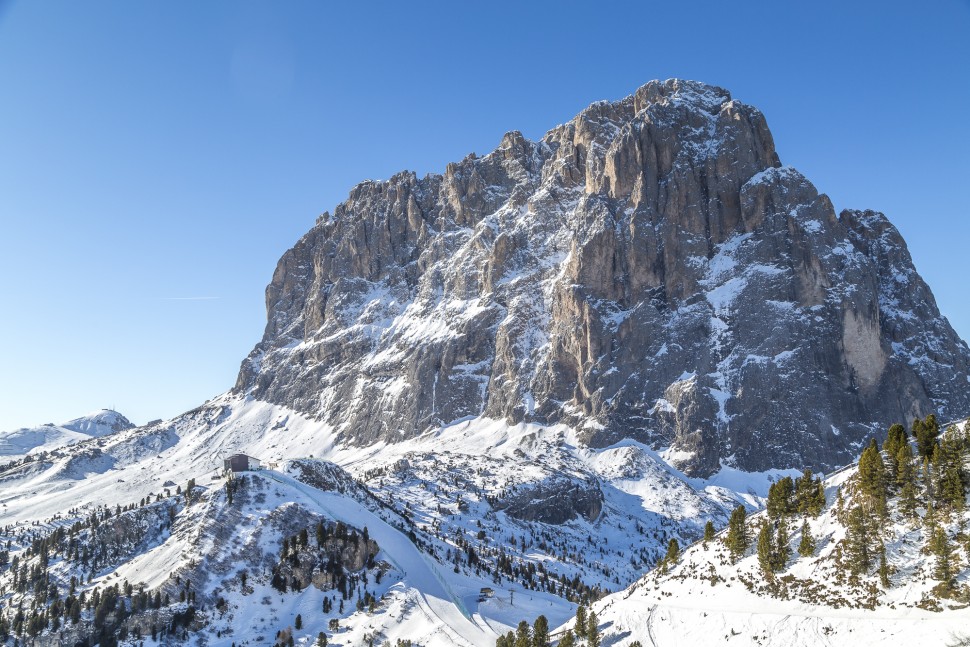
[0, 460, 574, 647]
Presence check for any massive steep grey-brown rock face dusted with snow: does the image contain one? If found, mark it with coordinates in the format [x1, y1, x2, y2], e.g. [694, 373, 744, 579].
[236, 80, 970, 475]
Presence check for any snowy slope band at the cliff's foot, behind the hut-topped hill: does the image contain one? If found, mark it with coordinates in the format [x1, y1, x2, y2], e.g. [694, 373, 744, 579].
[0, 395, 767, 590]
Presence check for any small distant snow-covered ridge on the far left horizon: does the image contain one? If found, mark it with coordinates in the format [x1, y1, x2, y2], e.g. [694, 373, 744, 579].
[0, 409, 134, 462]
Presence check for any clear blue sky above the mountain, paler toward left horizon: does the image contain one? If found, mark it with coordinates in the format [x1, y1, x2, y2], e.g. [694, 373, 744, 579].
[0, 0, 970, 429]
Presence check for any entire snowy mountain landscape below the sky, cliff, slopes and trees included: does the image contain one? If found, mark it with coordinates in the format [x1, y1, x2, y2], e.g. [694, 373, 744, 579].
[0, 79, 970, 647]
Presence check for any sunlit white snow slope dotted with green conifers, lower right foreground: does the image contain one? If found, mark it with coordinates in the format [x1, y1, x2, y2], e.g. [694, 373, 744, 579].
[584, 425, 970, 647]
